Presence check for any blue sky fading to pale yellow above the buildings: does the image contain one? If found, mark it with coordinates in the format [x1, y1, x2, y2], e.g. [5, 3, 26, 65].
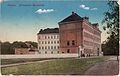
[0, 0, 108, 42]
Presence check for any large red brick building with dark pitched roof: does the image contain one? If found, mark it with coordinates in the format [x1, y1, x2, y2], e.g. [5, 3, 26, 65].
[58, 12, 101, 56]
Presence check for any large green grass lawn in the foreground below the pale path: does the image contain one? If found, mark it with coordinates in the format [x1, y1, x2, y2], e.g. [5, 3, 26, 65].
[1, 57, 106, 75]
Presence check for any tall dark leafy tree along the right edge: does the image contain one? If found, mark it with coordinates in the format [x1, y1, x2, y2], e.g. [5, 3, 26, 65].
[102, 1, 119, 55]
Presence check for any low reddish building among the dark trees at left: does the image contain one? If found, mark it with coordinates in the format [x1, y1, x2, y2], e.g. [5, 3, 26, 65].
[15, 43, 38, 55]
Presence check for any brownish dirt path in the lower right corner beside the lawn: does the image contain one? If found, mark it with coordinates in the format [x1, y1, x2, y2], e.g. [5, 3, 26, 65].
[85, 57, 119, 75]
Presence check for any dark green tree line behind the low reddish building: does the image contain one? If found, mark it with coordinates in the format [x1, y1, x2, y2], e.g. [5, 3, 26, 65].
[1, 41, 37, 54]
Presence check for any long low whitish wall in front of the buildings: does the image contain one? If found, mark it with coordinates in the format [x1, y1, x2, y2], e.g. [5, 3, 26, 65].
[0, 54, 78, 59]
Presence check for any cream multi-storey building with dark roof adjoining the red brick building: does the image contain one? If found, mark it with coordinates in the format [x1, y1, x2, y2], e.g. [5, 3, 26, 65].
[37, 28, 59, 54]
